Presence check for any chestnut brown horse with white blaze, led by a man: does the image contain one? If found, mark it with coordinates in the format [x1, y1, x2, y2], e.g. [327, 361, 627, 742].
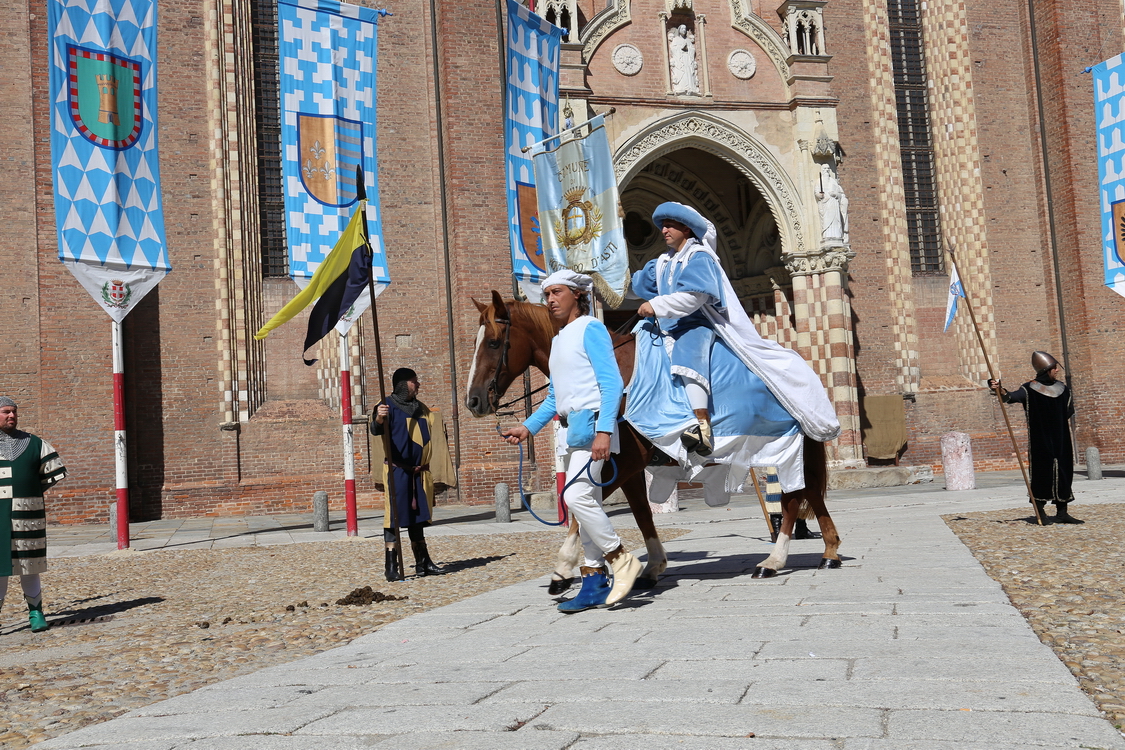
[465, 290, 840, 595]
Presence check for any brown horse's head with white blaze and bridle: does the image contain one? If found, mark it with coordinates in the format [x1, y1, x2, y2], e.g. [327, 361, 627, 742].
[465, 290, 555, 417]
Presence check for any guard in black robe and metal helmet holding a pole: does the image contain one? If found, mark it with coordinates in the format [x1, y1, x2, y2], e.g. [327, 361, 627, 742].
[989, 352, 1083, 524]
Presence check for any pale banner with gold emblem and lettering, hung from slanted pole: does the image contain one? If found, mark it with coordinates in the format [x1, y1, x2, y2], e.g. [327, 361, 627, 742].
[533, 115, 629, 307]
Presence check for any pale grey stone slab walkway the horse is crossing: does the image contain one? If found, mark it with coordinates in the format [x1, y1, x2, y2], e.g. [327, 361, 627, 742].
[35, 472, 1125, 750]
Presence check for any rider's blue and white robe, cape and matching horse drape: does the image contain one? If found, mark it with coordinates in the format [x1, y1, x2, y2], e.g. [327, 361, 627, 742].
[626, 223, 840, 493]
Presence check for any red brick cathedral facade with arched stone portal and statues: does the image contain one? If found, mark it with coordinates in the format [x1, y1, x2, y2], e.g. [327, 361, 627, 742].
[0, 0, 1125, 523]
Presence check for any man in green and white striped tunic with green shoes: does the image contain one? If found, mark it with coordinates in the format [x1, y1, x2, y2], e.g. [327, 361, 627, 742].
[0, 396, 66, 633]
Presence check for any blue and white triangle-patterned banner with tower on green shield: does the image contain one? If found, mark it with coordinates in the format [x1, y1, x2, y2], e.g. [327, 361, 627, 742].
[47, 0, 172, 323]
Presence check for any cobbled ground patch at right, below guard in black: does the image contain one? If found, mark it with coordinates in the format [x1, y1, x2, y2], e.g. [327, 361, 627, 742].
[943, 503, 1125, 731]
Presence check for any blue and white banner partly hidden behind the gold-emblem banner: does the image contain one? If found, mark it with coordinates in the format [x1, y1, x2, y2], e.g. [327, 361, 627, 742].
[504, 0, 563, 302]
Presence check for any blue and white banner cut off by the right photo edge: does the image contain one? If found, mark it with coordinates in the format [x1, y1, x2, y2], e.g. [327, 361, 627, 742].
[1091, 54, 1125, 297]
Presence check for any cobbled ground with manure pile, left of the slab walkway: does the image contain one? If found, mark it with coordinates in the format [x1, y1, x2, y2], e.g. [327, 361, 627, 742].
[0, 528, 661, 750]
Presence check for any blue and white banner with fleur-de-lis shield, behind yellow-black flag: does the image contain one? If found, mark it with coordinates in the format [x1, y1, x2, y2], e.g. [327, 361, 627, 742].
[278, 0, 390, 325]
